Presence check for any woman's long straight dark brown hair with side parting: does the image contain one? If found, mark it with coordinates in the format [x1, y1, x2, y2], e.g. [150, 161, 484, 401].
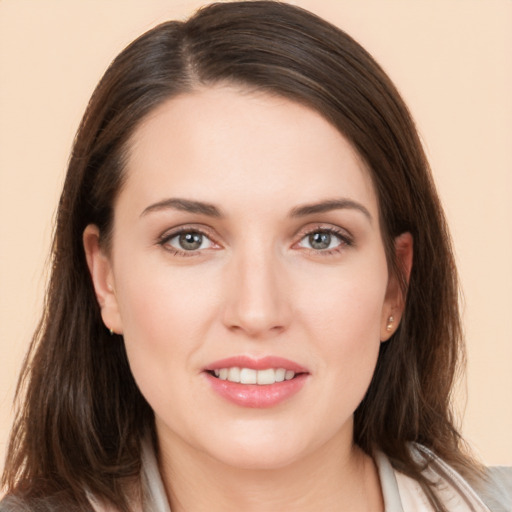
[2, 1, 476, 511]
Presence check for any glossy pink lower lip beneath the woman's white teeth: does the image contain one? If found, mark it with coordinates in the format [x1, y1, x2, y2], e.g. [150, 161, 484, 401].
[205, 373, 308, 409]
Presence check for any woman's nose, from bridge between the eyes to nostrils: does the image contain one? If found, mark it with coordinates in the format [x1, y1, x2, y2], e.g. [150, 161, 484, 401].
[223, 245, 292, 338]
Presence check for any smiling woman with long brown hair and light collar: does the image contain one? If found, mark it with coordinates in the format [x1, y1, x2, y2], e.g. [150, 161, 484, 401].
[1, 2, 507, 512]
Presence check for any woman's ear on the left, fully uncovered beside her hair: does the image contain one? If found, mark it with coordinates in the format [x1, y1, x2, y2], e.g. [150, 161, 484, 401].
[82, 224, 123, 334]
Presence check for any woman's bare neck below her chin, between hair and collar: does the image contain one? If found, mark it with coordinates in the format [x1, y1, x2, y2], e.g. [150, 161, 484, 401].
[156, 430, 384, 512]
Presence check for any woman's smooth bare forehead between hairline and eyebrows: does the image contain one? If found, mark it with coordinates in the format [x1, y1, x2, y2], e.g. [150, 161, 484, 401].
[121, 85, 378, 217]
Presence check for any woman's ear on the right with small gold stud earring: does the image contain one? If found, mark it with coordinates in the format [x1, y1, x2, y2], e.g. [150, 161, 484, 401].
[380, 233, 413, 341]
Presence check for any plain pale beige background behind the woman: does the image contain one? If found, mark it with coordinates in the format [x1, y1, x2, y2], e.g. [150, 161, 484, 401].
[0, 0, 512, 476]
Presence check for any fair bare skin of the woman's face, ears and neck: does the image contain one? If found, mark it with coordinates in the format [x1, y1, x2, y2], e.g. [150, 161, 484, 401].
[84, 85, 412, 512]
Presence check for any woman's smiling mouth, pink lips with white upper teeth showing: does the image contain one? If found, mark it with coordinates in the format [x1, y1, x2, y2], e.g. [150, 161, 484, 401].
[204, 356, 309, 408]
